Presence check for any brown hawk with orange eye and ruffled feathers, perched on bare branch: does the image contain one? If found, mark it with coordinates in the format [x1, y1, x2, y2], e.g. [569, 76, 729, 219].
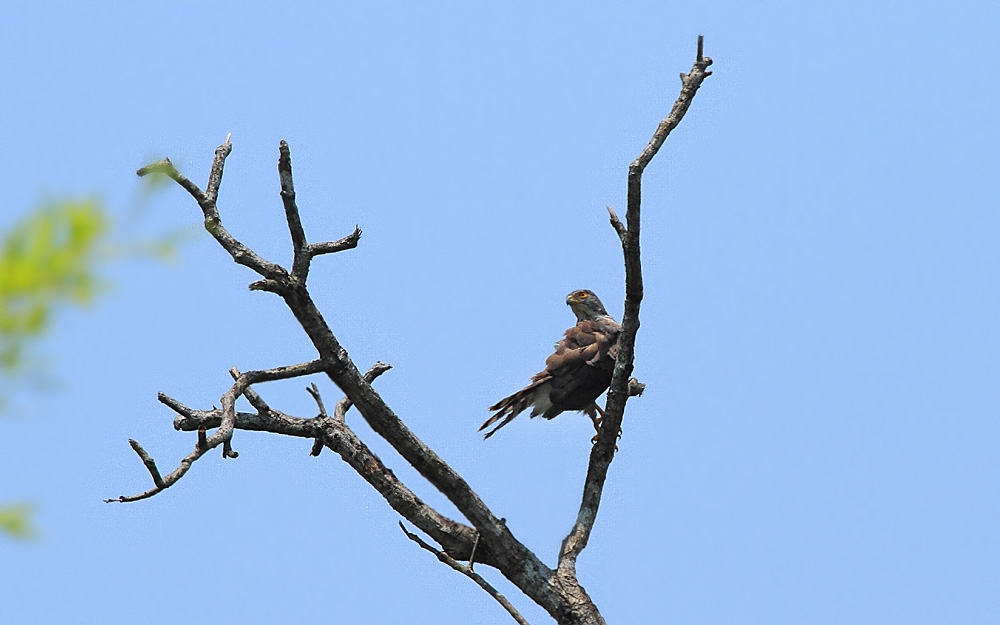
[479, 289, 622, 438]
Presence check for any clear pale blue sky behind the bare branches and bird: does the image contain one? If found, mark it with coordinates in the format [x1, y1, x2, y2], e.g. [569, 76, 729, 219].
[0, 2, 1000, 625]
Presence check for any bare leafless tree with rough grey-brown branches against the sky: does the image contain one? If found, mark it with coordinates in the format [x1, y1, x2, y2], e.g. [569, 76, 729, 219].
[106, 37, 712, 625]
